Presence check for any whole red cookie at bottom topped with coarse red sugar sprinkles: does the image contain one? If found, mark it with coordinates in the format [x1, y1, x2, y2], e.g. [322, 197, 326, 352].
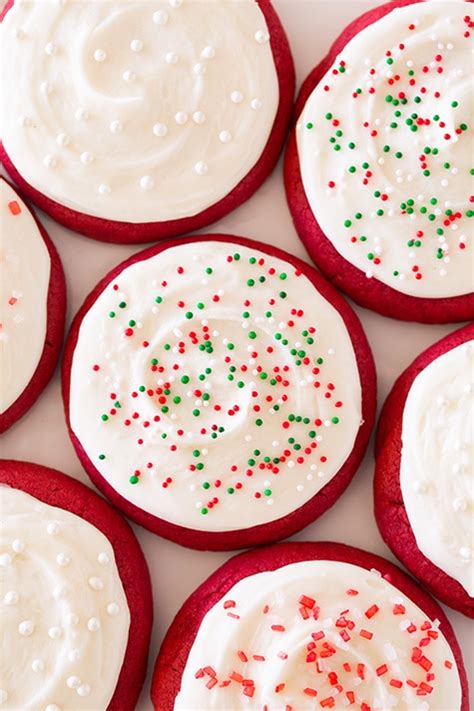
[151, 543, 469, 711]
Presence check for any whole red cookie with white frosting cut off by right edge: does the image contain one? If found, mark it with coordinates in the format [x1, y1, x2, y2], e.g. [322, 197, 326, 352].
[374, 324, 474, 617]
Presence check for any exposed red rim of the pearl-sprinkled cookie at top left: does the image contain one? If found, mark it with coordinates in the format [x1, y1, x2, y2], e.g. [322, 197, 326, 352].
[0, 0, 295, 244]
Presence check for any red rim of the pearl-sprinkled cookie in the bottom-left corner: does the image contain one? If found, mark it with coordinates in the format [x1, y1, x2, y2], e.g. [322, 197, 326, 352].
[0, 459, 153, 711]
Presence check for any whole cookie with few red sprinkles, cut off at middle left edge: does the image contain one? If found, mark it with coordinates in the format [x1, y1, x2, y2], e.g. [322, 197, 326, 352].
[0, 177, 66, 433]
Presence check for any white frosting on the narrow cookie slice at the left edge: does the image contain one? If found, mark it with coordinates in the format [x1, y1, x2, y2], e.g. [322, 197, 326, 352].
[0, 178, 51, 413]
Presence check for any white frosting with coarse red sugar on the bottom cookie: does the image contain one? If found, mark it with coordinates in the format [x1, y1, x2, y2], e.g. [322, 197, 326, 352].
[174, 560, 461, 711]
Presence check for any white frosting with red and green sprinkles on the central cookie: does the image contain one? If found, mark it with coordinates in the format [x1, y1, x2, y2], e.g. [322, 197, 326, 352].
[70, 242, 361, 531]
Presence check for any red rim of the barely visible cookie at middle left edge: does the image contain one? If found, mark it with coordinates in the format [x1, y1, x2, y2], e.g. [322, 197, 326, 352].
[0, 177, 67, 434]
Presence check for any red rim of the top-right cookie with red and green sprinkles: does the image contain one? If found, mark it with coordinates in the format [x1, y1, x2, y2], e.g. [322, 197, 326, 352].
[284, 0, 474, 323]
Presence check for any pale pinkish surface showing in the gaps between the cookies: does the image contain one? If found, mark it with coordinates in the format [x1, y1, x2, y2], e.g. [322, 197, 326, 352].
[0, 0, 474, 711]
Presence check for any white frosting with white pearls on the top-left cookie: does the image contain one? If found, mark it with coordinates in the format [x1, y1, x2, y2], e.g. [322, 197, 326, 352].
[0, 0, 279, 222]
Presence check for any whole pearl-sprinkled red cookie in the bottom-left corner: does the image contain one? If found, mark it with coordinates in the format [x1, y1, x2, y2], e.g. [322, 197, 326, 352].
[0, 460, 153, 711]
